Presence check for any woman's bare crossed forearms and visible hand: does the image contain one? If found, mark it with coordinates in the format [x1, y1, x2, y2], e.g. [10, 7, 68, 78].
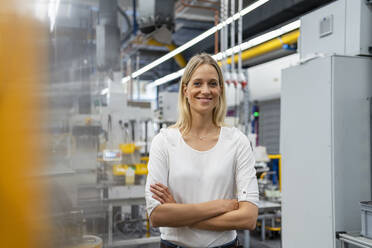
[150, 183, 258, 231]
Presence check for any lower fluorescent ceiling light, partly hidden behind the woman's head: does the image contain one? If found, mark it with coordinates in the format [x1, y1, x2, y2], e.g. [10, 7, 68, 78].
[147, 20, 301, 87]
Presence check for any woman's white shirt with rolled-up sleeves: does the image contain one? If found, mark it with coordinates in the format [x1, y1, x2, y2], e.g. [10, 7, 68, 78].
[146, 127, 258, 247]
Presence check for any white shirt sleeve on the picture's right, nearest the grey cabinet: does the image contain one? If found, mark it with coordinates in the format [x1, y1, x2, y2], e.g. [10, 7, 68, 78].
[235, 133, 259, 206]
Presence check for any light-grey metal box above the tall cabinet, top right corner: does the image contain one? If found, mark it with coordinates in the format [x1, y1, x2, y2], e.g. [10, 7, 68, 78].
[299, 0, 372, 59]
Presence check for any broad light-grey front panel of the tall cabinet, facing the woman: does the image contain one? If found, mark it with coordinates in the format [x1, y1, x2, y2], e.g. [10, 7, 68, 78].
[281, 58, 334, 248]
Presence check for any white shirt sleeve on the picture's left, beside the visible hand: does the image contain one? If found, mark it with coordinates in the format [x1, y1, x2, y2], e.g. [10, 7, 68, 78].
[145, 132, 168, 216]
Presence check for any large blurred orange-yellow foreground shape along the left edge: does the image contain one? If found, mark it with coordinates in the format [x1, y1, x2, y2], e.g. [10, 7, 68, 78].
[0, 0, 52, 248]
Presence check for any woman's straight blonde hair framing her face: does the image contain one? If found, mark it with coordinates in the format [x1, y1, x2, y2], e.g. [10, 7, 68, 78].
[172, 53, 227, 133]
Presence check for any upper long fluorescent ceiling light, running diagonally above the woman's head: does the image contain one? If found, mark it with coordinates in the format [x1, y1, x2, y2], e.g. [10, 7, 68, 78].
[122, 0, 269, 83]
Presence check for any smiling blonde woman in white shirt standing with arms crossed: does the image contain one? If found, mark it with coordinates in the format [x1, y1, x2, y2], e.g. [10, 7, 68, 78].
[146, 54, 258, 248]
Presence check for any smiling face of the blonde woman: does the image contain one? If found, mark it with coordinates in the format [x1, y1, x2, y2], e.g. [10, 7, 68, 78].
[184, 64, 221, 114]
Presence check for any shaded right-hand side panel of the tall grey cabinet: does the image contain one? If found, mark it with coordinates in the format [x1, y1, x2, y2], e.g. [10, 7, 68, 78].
[332, 56, 372, 236]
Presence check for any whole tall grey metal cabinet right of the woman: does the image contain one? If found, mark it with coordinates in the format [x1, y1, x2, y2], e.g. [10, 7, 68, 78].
[280, 55, 372, 248]
